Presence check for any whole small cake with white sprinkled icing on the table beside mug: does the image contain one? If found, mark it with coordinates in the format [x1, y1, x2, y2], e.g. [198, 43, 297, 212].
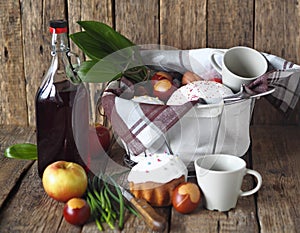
[128, 153, 188, 206]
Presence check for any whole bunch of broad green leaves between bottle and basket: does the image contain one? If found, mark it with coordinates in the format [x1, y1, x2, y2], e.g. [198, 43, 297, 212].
[70, 21, 149, 83]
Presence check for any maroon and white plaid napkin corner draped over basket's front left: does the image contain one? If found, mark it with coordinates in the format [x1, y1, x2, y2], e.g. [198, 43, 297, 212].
[102, 78, 195, 155]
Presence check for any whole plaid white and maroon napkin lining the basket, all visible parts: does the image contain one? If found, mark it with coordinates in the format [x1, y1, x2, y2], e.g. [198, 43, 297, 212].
[102, 48, 300, 155]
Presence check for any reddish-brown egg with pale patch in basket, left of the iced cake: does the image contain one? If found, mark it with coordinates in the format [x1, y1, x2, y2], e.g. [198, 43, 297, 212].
[153, 79, 176, 101]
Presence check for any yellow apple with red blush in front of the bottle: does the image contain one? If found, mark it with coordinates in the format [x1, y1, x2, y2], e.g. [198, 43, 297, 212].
[42, 161, 88, 202]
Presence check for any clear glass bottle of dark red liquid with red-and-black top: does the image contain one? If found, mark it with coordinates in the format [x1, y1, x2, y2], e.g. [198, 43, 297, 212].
[35, 20, 88, 177]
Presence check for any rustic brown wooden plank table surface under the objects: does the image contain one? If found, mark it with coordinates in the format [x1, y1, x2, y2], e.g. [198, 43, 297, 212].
[0, 125, 300, 233]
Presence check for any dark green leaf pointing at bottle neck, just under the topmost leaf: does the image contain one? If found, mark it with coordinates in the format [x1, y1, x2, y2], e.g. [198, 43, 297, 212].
[70, 32, 110, 60]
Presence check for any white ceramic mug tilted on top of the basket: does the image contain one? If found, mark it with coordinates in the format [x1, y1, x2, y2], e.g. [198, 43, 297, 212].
[210, 46, 268, 92]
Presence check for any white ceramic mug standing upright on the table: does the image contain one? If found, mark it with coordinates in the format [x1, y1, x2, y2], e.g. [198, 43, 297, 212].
[194, 154, 262, 211]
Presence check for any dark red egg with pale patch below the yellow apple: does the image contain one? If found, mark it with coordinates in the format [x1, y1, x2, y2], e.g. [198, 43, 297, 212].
[63, 198, 91, 225]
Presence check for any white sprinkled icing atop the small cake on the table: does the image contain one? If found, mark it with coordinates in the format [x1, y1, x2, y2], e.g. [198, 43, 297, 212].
[128, 153, 188, 184]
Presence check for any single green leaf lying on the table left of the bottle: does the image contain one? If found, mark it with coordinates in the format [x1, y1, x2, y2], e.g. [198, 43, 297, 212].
[4, 143, 37, 160]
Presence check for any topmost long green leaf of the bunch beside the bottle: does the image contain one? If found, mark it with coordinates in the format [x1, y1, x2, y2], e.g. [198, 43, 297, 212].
[78, 21, 134, 52]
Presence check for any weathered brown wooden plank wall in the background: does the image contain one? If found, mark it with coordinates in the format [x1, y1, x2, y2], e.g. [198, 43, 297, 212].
[0, 0, 300, 125]
